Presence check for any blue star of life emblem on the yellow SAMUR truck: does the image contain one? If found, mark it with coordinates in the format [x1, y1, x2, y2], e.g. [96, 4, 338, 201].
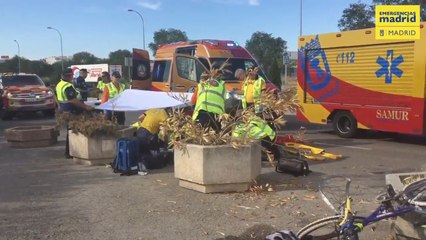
[376, 50, 404, 84]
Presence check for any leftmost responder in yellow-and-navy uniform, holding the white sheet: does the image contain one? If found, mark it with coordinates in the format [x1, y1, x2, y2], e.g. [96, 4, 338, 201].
[56, 68, 94, 158]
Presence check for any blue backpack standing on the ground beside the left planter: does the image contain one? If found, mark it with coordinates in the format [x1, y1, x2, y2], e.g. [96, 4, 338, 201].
[111, 138, 139, 175]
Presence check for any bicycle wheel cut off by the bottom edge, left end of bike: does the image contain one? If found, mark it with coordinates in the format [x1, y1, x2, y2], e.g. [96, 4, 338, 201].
[297, 215, 365, 240]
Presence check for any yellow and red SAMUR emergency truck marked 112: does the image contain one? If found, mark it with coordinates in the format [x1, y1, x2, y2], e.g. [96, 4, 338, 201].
[297, 22, 426, 137]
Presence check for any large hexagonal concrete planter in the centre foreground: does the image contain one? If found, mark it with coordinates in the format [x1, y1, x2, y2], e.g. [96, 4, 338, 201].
[174, 144, 262, 193]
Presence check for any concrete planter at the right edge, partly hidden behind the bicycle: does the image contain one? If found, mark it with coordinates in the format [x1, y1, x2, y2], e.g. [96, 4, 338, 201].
[386, 172, 426, 240]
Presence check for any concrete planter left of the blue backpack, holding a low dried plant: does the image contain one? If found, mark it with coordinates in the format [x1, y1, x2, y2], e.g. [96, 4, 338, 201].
[69, 127, 136, 165]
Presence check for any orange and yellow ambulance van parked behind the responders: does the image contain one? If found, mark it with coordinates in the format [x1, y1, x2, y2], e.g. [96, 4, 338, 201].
[133, 39, 278, 94]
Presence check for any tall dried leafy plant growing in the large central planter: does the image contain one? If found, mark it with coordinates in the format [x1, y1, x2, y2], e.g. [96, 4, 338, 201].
[160, 61, 297, 154]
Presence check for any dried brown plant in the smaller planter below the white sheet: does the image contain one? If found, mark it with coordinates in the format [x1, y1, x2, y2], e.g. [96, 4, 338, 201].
[56, 112, 119, 137]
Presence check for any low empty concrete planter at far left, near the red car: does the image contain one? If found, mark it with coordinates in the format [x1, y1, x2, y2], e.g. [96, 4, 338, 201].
[5, 126, 59, 148]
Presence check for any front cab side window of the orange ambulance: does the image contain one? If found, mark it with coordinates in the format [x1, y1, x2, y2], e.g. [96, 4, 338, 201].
[176, 56, 204, 82]
